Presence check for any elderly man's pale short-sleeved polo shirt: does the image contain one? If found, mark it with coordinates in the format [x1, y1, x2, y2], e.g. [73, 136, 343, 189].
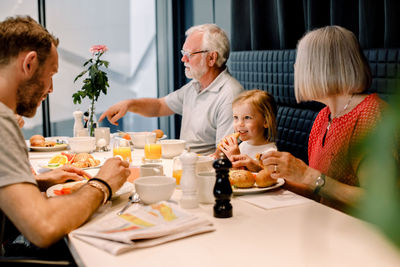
[165, 69, 244, 154]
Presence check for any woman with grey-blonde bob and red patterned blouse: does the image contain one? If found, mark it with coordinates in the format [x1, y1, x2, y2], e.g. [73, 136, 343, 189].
[261, 26, 385, 214]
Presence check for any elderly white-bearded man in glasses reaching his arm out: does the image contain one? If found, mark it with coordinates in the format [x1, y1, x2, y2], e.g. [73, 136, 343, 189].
[99, 24, 243, 154]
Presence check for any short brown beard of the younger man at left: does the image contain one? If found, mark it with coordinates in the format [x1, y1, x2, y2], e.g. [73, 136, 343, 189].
[16, 71, 44, 118]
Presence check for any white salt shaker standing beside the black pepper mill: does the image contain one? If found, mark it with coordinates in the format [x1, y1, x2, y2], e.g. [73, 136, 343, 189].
[179, 152, 199, 209]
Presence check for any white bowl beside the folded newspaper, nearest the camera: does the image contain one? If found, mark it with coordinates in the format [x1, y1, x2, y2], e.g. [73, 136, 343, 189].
[134, 176, 175, 204]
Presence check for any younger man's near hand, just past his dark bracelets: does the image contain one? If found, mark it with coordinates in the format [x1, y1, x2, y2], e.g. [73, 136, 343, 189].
[96, 157, 130, 193]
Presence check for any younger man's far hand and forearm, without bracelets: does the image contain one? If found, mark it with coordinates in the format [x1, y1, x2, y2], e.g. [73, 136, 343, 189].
[35, 165, 92, 191]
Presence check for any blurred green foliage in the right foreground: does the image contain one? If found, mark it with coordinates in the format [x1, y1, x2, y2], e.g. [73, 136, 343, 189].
[354, 94, 400, 247]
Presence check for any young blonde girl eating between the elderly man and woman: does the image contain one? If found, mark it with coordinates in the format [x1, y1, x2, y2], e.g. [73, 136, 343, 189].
[219, 89, 277, 171]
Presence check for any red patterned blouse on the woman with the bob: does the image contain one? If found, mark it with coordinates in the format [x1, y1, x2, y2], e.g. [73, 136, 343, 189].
[308, 94, 385, 186]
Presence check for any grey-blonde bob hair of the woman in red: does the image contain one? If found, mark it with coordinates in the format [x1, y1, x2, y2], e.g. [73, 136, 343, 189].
[294, 26, 371, 102]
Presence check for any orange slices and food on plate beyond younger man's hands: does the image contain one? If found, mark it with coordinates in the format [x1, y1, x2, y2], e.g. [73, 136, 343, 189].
[47, 153, 100, 168]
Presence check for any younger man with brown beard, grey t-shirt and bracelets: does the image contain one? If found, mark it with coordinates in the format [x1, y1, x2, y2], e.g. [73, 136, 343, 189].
[0, 16, 130, 254]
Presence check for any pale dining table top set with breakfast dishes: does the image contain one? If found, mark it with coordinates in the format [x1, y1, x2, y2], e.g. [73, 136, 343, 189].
[29, 143, 400, 267]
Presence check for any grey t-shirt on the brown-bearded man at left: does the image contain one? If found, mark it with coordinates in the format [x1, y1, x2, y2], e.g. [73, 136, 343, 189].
[0, 102, 37, 187]
